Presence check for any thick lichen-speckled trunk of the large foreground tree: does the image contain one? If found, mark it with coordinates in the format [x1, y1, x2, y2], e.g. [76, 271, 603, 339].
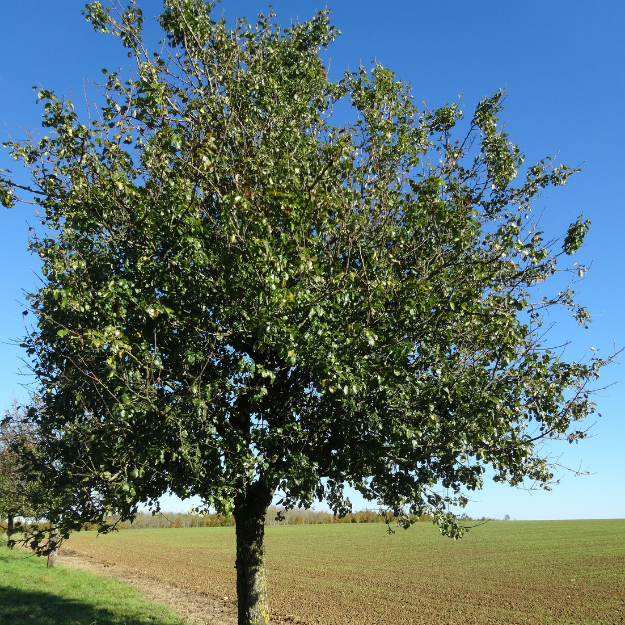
[234, 480, 273, 625]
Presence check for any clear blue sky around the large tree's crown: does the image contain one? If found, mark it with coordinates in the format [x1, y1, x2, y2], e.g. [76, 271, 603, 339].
[0, 0, 625, 519]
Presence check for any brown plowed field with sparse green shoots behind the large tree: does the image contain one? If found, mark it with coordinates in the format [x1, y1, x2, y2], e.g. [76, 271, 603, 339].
[66, 520, 625, 625]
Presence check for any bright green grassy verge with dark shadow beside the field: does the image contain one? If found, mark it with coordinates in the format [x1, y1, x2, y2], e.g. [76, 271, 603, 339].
[0, 542, 186, 625]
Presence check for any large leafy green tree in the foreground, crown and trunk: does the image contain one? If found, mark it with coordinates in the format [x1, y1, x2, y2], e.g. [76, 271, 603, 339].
[0, 0, 607, 624]
